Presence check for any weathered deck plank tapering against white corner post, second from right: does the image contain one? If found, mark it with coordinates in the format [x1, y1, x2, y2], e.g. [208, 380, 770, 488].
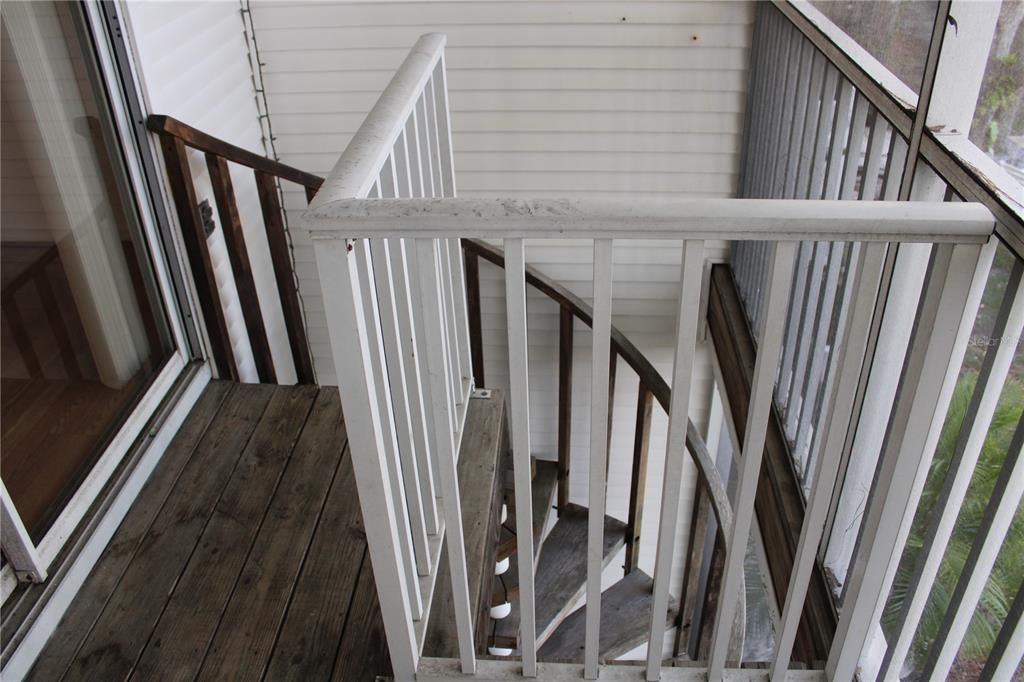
[265, 399, 367, 682]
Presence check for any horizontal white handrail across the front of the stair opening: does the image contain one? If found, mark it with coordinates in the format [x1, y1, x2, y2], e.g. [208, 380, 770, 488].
[302, 195, 995, 244]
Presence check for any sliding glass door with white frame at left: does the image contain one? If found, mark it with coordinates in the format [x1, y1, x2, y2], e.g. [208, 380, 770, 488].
[0, 2, 192, 573]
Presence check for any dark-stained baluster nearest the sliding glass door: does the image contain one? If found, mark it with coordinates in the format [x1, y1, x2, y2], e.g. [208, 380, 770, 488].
[160, 135, 239, 381]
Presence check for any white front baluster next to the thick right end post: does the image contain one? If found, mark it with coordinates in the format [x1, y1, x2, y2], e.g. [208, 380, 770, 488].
[769, 244, 886, 682]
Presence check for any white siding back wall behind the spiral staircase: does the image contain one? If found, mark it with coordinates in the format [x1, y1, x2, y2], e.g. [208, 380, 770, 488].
[253, 0, 754, 622]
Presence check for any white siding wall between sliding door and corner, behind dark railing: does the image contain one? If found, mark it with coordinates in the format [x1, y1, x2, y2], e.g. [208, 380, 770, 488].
[125, 2, 295, 383]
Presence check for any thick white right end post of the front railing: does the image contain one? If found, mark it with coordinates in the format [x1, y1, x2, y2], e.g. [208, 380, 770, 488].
[825, 238, 994, 680]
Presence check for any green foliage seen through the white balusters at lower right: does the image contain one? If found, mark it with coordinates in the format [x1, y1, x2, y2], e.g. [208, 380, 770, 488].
[882, 371, 1024, 665]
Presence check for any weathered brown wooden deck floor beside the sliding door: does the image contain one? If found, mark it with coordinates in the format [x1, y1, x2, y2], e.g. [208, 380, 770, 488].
[30, 382, 390, 682]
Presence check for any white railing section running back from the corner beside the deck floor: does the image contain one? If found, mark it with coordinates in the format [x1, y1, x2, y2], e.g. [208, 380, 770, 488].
[301, 34, 472, 671]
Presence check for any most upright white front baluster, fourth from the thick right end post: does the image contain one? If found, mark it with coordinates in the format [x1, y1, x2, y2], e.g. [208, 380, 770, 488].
[583, 240, 612, 680]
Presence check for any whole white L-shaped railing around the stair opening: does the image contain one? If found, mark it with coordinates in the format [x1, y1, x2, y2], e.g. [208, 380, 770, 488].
[302, 29, 1007, 680]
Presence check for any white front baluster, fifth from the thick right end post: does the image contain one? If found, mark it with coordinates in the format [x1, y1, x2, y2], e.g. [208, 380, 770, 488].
[505, 240, 537, 677]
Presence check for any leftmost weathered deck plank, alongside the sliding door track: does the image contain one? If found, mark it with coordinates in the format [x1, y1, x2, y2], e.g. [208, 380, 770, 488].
[29, 381, 234, 681]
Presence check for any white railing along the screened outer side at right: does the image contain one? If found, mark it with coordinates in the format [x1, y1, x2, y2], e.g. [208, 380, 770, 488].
[731, 2, 1024, 681]
